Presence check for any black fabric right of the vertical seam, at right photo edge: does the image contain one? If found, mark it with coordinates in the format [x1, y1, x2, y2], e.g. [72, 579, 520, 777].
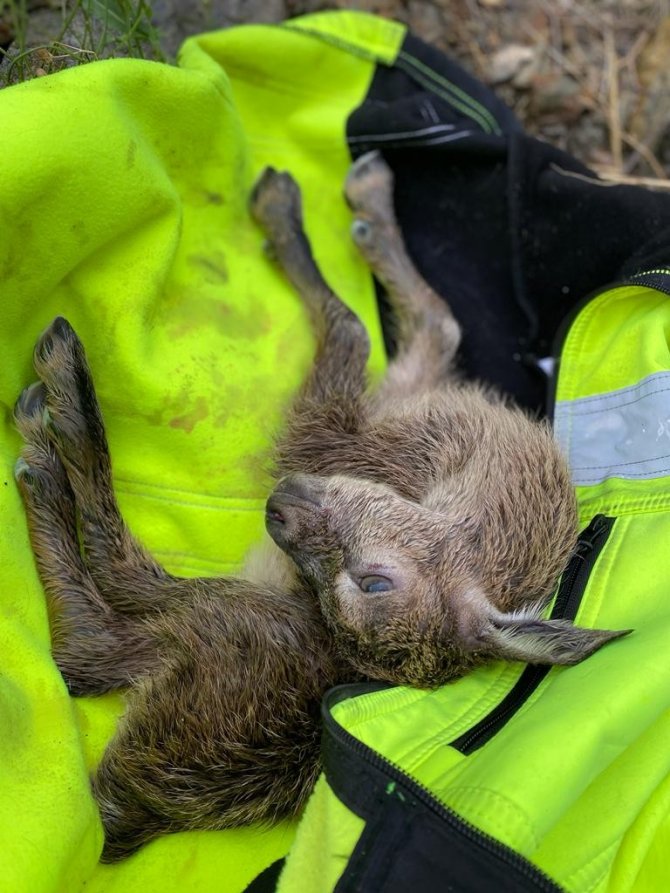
[512, 136, 670, 343]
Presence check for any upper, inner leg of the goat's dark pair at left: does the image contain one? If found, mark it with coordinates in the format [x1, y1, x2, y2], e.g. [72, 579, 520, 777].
[28, 318, 186, 614]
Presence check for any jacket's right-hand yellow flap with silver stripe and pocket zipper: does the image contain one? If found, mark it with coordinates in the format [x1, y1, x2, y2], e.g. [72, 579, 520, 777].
[279, 269, 670, 893]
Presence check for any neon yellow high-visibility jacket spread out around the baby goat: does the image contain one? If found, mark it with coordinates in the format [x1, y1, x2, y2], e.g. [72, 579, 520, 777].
[0, 11, 670, 893]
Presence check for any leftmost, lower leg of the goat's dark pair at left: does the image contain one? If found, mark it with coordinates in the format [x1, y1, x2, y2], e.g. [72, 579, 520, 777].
[14, 382, 158, 694]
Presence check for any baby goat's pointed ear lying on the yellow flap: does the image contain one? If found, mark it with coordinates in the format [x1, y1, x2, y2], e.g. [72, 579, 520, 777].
[479, 611, 632, 664]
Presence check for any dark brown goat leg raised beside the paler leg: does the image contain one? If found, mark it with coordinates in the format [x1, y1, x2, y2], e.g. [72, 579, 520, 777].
[250, 168, 370, 474]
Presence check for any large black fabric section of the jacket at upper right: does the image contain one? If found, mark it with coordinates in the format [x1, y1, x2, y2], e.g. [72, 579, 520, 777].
[347, 36, 670, 412]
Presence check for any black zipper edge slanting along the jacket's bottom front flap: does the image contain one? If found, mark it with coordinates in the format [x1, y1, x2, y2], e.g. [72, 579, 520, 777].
[325, 711, 562, 893]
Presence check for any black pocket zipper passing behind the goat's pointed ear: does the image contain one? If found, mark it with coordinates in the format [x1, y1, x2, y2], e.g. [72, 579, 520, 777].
[450, 515, 615, 756]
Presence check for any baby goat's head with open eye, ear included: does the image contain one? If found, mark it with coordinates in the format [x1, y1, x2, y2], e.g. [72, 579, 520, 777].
[266, 474, 620, 687]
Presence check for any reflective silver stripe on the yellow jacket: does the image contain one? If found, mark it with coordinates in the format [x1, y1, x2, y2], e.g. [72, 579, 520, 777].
[554, 372, 670, 484]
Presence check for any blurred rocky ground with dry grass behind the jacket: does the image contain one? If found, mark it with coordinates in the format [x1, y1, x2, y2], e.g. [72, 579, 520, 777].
[0, 0, 670, 180]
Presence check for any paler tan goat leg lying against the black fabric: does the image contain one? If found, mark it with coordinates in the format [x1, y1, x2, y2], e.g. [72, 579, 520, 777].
[344, 152, 461, 398]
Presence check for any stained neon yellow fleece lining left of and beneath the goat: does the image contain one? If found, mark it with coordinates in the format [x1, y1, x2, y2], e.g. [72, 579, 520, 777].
[0, 13, 403, 893]
